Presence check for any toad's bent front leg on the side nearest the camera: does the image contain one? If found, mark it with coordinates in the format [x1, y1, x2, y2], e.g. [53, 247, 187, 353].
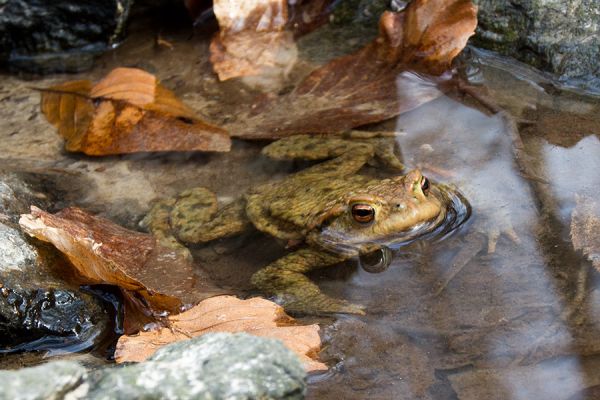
[252, 248, 365, 315]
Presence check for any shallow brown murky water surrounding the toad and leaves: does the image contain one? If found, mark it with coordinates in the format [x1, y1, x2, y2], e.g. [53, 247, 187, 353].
[0, 3, 600, 400]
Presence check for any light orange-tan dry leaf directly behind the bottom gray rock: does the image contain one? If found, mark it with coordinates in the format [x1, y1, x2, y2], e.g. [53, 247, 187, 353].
[115, 296, 327, 371]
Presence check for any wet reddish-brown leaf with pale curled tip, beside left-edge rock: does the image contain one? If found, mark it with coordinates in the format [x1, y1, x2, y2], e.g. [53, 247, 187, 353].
[19, 206, 229, 329]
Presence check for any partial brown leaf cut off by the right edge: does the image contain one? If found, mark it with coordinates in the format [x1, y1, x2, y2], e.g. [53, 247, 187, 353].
[571, 194, 600, 271]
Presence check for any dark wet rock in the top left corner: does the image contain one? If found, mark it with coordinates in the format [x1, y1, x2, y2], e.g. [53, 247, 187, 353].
[0, 0, 133, 73]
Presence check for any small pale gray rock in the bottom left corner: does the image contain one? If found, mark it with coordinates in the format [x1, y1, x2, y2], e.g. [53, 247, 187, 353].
[0, 361, 88, 400]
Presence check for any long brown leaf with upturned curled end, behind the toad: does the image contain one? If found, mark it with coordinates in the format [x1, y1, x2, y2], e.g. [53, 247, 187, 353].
[229, 0, 477, 139]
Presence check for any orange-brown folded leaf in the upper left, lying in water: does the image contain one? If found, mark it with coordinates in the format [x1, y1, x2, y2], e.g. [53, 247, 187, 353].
[41, 68, 231, 156]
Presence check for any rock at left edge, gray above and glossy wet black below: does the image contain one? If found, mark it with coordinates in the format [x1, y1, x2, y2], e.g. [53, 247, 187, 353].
[0, 173, 109, 353]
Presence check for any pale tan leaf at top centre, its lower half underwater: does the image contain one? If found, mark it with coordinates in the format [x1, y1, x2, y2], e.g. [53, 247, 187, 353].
[210, 0, 298, 88]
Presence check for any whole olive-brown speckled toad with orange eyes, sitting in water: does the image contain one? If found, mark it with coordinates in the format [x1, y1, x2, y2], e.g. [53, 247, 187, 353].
[145, 133, 452, 314]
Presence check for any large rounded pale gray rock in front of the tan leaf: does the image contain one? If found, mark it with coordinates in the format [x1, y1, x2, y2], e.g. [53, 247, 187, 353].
[90, 333, 306, 400]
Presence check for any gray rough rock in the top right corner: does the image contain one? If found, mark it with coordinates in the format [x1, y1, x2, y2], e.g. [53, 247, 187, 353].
[475, 0, 600, 90]
